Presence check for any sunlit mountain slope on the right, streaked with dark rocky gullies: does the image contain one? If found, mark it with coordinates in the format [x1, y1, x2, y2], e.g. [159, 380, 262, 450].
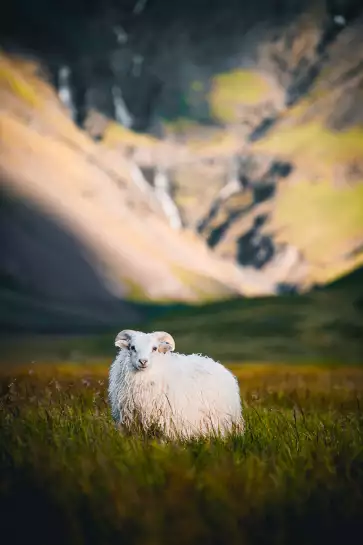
[154, 8, 363, 289]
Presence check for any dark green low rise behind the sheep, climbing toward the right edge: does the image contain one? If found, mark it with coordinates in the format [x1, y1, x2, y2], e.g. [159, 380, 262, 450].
[142, 270, 363, 364]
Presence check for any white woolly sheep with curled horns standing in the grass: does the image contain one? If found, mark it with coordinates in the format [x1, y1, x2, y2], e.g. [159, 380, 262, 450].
[108, 329, 244, 439]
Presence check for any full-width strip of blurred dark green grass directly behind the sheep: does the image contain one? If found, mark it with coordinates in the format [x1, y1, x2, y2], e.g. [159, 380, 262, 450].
[0, 269, 363, 365]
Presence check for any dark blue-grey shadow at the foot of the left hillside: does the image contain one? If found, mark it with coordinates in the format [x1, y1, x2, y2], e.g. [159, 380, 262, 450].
[0, 185, 162, 333]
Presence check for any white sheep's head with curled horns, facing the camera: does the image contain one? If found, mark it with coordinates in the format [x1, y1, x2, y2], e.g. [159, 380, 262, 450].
[115, 329, 175, 371]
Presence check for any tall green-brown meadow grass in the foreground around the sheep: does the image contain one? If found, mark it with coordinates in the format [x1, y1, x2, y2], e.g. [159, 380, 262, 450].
[0, 362, 363, 545]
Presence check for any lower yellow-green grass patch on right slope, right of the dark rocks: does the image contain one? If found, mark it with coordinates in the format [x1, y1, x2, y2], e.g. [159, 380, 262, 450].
[269, 181, 363, 274]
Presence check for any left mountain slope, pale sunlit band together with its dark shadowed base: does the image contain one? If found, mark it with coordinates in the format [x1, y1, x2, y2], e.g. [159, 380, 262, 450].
[0, 56, 282, 330]
